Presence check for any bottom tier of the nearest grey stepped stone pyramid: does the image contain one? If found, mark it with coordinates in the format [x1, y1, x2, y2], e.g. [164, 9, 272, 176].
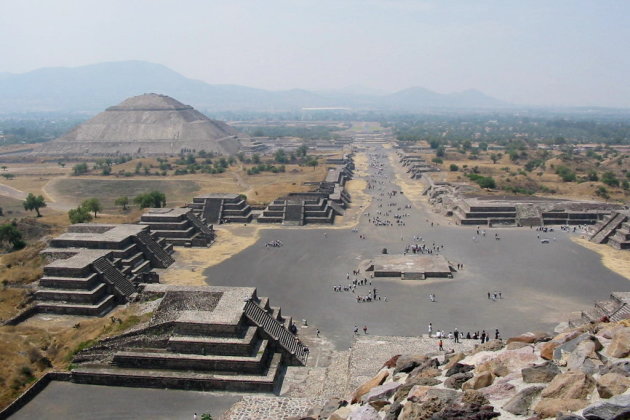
[72, 353, 283, 392]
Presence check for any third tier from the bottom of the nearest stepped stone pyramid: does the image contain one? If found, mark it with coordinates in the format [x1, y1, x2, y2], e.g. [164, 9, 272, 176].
[168, 327, 258, 356]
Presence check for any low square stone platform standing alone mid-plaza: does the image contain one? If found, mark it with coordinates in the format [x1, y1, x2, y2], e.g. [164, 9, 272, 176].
[367, 254, 454, 280]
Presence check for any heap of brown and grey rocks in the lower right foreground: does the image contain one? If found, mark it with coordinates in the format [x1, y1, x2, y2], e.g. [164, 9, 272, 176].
[312, 321, 630, 420]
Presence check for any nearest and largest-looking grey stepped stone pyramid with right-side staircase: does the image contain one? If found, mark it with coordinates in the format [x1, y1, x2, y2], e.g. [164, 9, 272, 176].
[72, 285, 308, 392]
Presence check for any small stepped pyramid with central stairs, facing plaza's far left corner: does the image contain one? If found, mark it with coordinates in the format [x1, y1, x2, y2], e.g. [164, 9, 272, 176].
[188, 193, 252, 224]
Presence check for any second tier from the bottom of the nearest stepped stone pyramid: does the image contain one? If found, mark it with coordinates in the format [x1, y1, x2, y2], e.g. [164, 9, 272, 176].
[113, 340, 271, 374]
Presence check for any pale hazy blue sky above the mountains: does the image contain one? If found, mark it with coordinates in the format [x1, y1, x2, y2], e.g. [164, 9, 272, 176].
[0, 0, 630, 107]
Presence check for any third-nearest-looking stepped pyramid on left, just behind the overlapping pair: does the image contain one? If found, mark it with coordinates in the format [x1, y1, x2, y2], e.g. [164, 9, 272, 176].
[140, 208, 215, 247]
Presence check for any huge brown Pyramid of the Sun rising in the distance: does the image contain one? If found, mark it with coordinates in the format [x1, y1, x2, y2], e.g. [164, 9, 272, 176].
[36, 93, 240, 156]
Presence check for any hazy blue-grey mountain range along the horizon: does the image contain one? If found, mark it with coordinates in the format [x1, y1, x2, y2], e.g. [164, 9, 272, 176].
[0, 61, 507, 113]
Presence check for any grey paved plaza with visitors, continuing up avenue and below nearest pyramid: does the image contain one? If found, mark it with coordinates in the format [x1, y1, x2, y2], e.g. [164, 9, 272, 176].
[7, 145, 628, 419]
